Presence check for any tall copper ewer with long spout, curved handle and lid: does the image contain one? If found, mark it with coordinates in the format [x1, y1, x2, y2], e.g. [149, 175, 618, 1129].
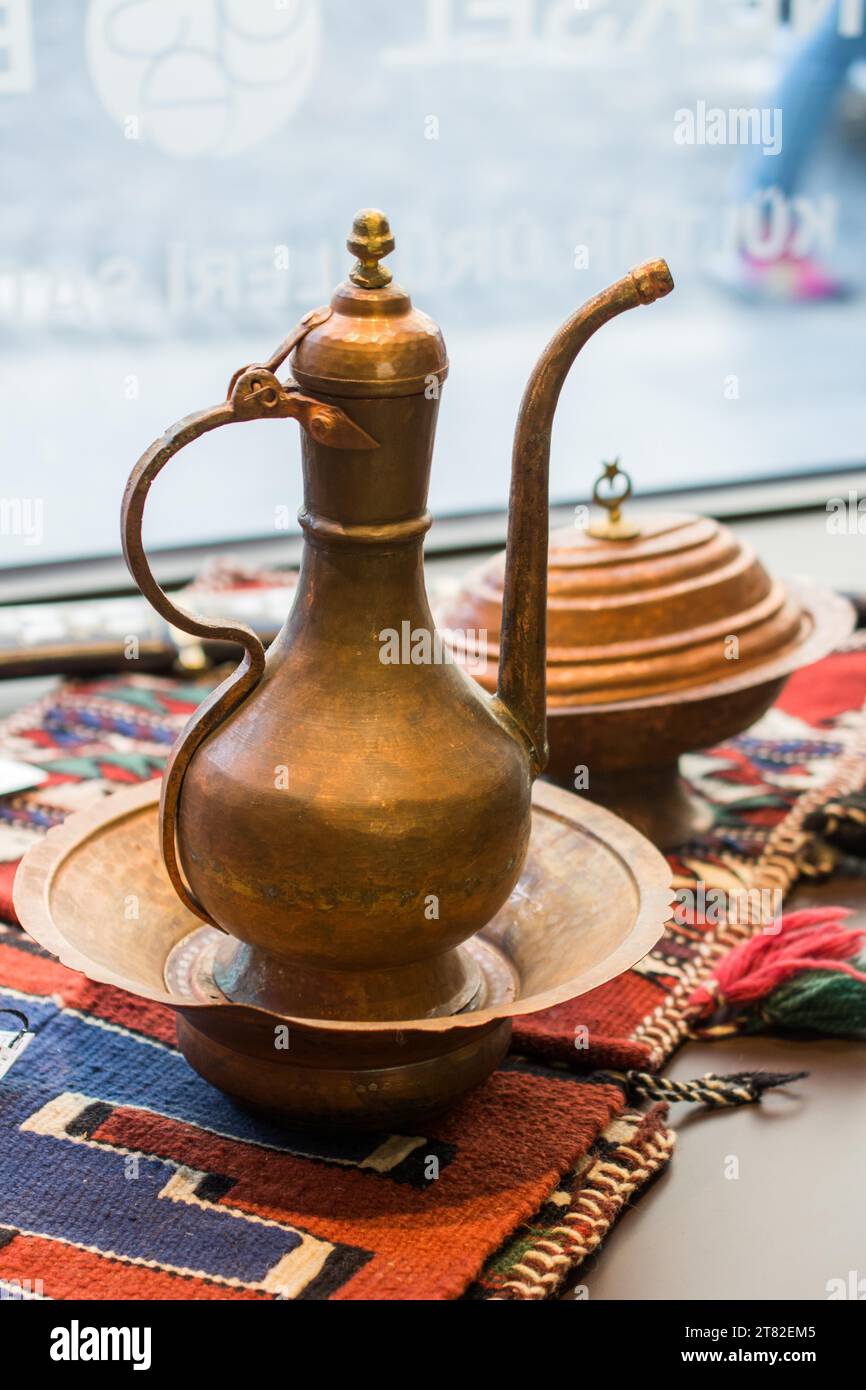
[111, 211, 673, 1113]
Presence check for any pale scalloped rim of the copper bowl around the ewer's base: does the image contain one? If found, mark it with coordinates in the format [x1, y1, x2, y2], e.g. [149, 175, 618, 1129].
[13, 778, 674, 1036]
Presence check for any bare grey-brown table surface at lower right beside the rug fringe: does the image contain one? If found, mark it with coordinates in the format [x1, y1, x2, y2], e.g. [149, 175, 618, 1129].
[575, 877, 866, 1300]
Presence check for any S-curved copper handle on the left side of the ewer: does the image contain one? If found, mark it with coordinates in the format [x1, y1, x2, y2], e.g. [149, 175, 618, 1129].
[121, 326, 378, 926]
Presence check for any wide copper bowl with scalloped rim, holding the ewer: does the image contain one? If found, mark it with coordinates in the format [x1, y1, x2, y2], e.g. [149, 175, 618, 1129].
[14, 783, 671, 1130]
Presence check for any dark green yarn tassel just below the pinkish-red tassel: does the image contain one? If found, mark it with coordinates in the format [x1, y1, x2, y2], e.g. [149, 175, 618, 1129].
[742, 959, 866, 1037]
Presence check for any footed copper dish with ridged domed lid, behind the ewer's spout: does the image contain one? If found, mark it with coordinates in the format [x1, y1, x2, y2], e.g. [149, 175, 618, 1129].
[439, 514, 855, 848]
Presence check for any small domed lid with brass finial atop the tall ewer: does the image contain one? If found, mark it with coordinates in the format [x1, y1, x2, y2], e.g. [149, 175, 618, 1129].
[292, 209, 448, 396]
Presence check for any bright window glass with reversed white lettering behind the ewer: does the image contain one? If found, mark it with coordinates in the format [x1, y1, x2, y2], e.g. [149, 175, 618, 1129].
[0, 0, 866, 564]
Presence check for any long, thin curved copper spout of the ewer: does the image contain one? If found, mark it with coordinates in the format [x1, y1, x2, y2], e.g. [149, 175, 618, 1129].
[498, 260, 674, 773]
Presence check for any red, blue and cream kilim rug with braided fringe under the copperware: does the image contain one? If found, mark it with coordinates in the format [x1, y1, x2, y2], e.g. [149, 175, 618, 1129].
[0, 651, 866, 1300]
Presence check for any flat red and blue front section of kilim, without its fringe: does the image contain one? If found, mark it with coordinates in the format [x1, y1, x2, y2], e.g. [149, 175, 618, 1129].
[0, 927, 623, 1300]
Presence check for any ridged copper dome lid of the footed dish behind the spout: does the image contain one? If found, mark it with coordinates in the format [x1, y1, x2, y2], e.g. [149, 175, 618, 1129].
[442, 464, 812, 712]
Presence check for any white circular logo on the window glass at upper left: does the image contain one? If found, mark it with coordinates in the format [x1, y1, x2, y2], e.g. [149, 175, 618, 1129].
[85, 0, 321, 158]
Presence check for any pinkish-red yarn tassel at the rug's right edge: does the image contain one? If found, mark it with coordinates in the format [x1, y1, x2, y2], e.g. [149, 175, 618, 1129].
[688, 908, 866, 1017]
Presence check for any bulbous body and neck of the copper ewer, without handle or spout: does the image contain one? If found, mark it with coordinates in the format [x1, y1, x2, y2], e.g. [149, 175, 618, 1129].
[178, 396, 532, 1019]
